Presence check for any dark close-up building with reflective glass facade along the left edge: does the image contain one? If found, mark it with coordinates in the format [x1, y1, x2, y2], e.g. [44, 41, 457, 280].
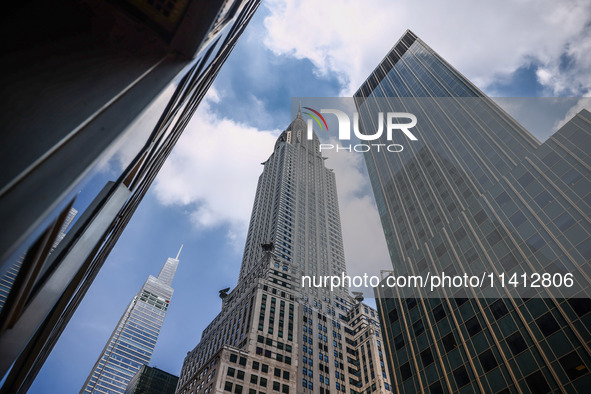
[0, 0, 260, 393]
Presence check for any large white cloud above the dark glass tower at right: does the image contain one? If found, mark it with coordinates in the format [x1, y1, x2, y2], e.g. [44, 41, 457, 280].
[265, 0, 591, 95]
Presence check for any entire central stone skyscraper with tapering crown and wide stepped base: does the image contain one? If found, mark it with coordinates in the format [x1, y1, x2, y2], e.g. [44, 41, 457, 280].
[177, 111, 390, 394]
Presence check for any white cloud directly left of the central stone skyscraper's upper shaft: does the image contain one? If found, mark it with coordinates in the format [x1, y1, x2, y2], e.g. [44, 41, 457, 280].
[153, 89, 278, 247]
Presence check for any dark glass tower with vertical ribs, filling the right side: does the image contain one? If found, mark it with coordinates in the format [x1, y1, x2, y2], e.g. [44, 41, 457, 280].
[355, 31, 591, 393]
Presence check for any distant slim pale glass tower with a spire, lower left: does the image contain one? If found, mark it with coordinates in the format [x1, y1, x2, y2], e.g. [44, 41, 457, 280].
[80, 251, 183, 394]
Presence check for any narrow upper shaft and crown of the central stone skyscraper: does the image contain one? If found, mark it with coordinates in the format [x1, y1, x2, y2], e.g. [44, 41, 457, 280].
[239, 110, 348, 292]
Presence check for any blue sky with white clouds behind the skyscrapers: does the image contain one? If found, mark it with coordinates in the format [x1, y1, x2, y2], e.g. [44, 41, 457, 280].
[30, 0, 591, 393]
